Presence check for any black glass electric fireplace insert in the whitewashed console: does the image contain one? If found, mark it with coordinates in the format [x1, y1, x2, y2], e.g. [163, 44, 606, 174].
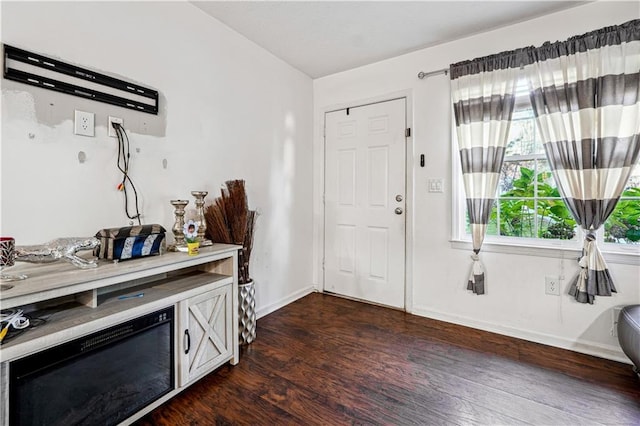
[9, 307, 174, 426]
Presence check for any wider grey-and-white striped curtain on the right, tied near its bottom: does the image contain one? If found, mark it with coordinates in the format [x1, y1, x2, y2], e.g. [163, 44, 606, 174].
[526, 20, 640, 303]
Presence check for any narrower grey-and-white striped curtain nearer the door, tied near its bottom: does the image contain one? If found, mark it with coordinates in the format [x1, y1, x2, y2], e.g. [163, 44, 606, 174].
[450, 52, 518, 294]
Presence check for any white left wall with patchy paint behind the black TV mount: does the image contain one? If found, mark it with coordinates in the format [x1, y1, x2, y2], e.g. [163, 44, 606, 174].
[0, 1, 313, 315]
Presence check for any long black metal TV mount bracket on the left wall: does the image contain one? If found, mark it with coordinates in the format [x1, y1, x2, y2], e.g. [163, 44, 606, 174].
[4, 44, 158, 115]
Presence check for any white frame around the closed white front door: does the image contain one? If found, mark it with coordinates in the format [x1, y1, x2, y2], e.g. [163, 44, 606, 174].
[313, 90, 418, 313]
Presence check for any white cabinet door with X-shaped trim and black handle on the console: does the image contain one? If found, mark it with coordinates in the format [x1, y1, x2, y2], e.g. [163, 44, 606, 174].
[178, 285, 233, 386]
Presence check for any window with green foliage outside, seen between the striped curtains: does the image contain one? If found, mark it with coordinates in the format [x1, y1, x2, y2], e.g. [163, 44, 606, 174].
[454, 81, 640, 252]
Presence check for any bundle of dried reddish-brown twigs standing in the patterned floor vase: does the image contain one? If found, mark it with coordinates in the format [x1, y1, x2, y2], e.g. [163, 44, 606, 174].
[204, 180, 258, 284]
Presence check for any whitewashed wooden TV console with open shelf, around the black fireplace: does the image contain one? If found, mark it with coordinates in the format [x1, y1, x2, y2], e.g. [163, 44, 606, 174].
[0, 244, 241, 425]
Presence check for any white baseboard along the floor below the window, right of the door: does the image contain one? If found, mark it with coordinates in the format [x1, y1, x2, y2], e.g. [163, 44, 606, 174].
[412, 306, 632, 364]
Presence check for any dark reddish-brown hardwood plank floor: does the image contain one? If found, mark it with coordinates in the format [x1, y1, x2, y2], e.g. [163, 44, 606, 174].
[138, 294, 640, 425]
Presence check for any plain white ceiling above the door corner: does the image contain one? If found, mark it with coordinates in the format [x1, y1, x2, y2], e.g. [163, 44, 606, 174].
[192, 0, 585, 78]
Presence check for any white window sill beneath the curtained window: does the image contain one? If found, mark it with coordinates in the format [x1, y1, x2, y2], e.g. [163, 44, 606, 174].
[449, 240, 640, 266]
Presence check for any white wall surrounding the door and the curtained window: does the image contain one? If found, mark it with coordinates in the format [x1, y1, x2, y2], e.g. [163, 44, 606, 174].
[314, 2, 640, 360]
